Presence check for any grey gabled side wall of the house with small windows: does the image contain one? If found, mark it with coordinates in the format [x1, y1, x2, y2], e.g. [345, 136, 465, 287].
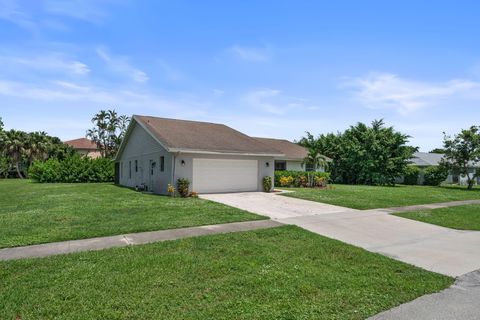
[117, 124, 173, 194]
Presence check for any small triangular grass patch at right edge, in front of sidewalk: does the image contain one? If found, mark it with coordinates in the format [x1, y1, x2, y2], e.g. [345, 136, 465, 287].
[395, 204, 480, 231]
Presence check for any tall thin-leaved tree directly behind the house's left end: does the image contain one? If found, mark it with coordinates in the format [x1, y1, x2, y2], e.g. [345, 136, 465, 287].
[87, 110, 130, 158]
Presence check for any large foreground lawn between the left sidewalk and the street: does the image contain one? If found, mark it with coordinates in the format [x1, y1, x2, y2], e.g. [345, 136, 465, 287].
[0, 226, 453, 320]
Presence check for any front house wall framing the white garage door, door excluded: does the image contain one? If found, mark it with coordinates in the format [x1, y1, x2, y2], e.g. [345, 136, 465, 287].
[174, 153, 275, 191]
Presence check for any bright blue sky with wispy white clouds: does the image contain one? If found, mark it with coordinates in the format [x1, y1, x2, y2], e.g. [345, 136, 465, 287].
[0, 0, 480, 151]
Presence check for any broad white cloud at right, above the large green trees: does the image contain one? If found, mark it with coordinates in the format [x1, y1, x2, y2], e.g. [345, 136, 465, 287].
[344, 73, 480, 115]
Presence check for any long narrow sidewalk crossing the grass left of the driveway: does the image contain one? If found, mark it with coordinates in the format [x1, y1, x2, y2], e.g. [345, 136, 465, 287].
[0, 220, 282, 260]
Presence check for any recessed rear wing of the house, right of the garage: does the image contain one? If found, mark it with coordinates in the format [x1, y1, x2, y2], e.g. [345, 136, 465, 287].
[255, 138, 329, 171]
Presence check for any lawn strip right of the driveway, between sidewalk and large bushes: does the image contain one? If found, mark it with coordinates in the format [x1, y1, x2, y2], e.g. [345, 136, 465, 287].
[280, 184, 480, 209]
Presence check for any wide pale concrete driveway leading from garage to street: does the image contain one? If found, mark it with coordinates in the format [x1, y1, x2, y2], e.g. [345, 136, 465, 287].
[201, 192, 480, 277]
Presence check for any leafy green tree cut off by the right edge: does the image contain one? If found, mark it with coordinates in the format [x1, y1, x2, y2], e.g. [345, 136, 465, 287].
[441, 126, 480, 189]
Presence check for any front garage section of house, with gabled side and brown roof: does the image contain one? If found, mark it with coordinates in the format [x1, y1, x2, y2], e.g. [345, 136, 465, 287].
[115, 115, 284, 194]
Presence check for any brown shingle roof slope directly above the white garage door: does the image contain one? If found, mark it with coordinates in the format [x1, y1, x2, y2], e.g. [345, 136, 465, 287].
[133, 115, 282, 155]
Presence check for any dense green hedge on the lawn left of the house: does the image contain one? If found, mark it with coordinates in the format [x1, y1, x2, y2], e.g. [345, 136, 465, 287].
[29, 155, 114, 183]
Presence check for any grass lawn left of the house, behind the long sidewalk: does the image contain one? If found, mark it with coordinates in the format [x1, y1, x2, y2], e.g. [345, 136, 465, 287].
[0, 180, 265, 248]
